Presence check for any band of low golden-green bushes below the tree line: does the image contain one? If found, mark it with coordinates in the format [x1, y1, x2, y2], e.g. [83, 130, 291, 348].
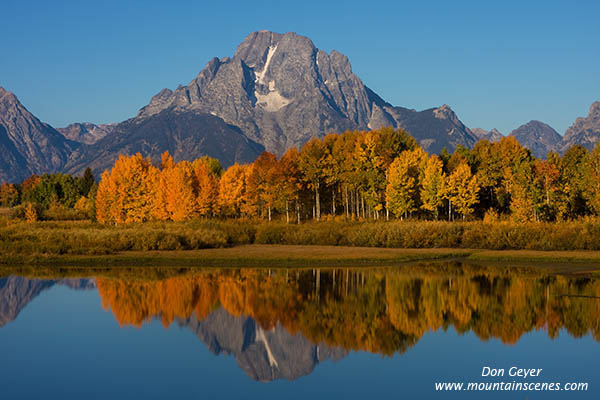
[0, 219, 600, 257]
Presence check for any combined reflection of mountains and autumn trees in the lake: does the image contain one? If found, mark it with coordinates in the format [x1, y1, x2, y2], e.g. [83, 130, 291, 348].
[0, 263, 600, 381]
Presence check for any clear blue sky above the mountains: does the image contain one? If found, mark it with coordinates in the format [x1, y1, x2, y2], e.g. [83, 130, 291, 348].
[0, 0, 600, 134]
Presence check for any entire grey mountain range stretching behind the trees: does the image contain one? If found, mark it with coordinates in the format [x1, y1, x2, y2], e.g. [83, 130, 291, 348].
[0, 31, 600, 182]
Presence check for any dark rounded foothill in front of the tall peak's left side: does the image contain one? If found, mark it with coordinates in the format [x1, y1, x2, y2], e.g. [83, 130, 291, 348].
[63, 109, 264, 176]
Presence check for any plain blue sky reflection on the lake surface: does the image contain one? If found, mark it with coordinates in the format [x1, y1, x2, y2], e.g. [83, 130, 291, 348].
[0, 270, 600, 399]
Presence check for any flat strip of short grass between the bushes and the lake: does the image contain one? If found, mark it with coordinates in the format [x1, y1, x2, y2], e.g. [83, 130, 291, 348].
[0, 244, 600, 269]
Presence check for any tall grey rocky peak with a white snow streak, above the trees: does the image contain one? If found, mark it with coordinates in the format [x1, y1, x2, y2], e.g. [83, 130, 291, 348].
[136, 31, 476, 154]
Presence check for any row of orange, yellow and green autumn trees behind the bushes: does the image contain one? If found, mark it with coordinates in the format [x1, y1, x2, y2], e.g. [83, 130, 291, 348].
[0, 128, 600, 223]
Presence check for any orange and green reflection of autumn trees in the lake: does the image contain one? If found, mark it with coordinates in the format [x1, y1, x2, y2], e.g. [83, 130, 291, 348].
[97, 263, 600, 355]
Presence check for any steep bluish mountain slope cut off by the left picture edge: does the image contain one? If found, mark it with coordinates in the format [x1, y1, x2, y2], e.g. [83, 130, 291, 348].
[0, 87, 79, 182]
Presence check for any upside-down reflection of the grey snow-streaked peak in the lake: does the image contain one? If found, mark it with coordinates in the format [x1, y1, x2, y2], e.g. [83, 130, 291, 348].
[179, 308, 347, 382]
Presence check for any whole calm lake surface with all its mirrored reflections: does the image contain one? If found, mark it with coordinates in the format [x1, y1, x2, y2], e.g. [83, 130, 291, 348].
[0, 262, 600, 400]
